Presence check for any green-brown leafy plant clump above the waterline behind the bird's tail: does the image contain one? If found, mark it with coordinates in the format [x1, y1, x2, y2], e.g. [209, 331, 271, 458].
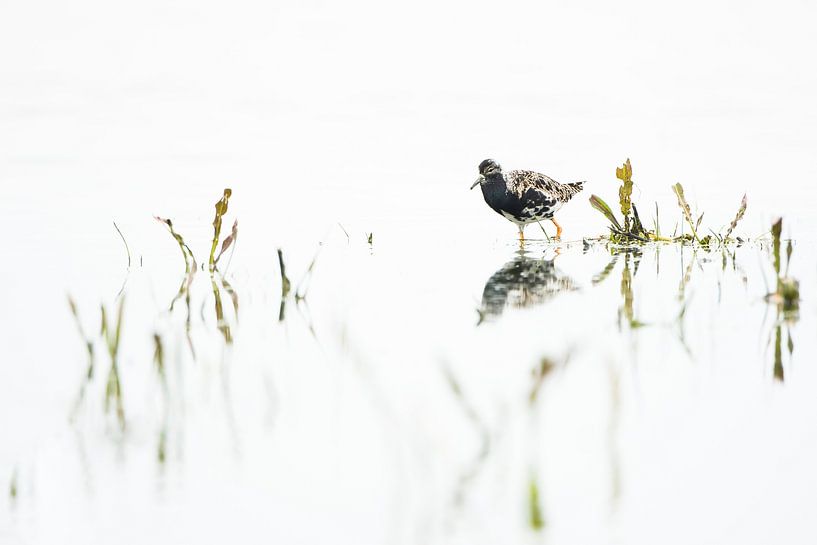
[590, 159, 746, 246]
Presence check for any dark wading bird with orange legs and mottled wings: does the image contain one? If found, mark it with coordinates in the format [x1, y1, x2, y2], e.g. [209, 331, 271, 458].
[471, 159, 585, 242]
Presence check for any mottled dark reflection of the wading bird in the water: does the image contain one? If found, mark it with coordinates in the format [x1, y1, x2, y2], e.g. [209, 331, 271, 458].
[479, 252, 578, 323]
